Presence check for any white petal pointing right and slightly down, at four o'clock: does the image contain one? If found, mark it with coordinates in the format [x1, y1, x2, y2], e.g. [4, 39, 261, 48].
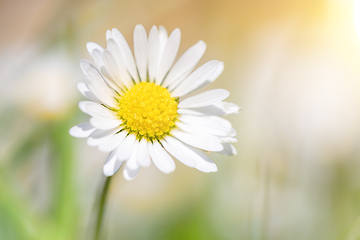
[171, 129, 223, 152]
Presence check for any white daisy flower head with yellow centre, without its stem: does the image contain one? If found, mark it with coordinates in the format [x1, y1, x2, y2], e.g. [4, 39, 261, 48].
[70, 25, 239, 180]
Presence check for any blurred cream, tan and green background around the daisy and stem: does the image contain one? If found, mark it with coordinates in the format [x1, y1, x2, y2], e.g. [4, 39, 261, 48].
[0, 0, 360, 240]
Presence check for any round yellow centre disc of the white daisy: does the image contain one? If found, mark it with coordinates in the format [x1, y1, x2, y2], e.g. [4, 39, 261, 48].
[118, 82, 178, 141]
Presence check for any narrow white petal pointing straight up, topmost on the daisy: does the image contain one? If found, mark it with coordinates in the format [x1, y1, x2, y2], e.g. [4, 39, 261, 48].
[134, 25, 147, 82]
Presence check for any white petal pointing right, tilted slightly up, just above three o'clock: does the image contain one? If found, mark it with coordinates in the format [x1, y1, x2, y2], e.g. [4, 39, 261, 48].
[178, 89, 230, 108]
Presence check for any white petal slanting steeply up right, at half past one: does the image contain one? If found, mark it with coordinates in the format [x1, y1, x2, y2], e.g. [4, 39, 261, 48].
[163, 41, 206, 87]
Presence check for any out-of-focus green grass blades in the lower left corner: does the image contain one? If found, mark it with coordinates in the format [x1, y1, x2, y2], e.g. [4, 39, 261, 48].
[0, 113, 79, 239]
